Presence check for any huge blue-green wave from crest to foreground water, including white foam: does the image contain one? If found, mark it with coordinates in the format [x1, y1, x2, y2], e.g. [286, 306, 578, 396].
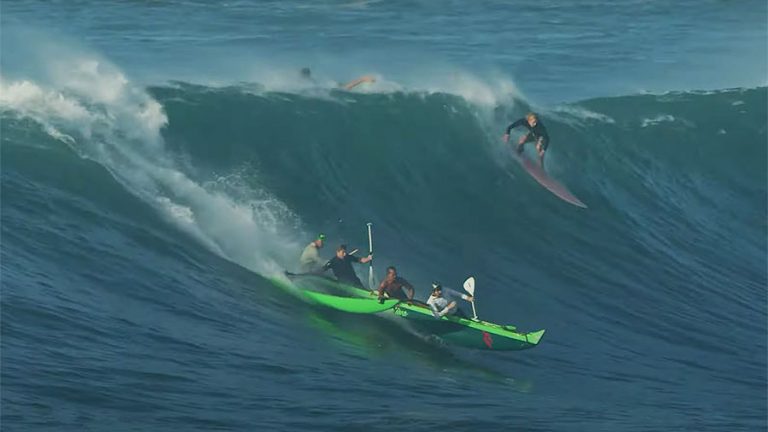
[0, 69, 768, 430]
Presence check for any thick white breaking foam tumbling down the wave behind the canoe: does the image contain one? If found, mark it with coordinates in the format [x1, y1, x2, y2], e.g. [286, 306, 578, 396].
[0, 44, 300, 274]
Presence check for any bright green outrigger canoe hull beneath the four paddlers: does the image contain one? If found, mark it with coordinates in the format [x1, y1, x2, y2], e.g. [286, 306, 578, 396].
[288, 274, 545, 351]
